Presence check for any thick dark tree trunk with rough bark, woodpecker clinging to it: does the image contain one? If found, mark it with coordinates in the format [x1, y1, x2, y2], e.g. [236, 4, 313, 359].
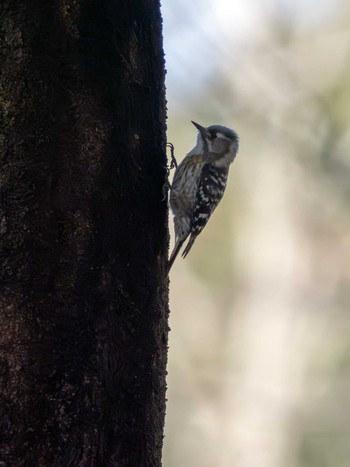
[0, 0, 168, 467]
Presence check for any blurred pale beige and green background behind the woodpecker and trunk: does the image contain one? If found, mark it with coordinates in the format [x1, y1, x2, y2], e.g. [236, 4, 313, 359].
[162, 0, 350, 467]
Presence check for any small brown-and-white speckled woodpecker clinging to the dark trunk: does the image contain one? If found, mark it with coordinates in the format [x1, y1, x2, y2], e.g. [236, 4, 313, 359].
[168, 121, 239, 271]
